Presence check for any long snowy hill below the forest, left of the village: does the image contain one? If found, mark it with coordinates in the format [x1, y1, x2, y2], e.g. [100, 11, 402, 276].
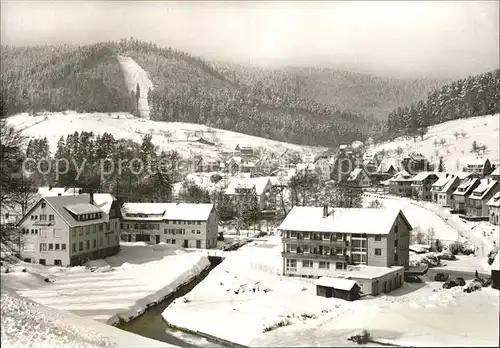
[7, 111, 319, 158]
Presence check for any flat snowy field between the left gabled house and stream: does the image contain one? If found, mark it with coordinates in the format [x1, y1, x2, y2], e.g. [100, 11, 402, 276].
[1, 243, 210, 324]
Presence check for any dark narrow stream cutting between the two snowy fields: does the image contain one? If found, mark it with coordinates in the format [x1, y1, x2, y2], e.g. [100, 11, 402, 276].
[116, 257, 222, 347]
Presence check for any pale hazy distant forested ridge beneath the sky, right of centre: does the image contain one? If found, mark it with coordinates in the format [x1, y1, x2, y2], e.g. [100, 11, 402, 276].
[212, 62, 451, 120]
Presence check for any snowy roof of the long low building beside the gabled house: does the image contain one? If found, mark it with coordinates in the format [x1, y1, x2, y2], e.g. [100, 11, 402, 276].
[122, 203, 213, 221]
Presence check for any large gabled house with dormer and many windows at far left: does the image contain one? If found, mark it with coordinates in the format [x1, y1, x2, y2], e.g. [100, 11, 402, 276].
[17, 194, 120, 266]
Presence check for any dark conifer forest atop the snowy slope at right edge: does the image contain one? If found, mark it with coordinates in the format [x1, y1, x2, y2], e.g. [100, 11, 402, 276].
[387, 70, 500, 138]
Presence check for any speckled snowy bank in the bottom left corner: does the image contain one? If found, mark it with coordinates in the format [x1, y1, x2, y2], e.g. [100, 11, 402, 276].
[1, 288, 173, 348]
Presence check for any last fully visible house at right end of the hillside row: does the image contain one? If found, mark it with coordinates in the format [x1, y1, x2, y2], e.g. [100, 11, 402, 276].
[465, 178, 500, 220]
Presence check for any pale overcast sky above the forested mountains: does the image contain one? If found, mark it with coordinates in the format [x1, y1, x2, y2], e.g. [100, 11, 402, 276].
[1, 0, 499, 77]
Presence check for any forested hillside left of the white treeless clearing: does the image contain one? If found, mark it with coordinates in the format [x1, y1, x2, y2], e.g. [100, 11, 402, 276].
[1, 44, 134, 116]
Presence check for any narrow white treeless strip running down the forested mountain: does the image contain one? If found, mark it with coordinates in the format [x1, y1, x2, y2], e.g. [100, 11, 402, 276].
[118, 56, 153, 119]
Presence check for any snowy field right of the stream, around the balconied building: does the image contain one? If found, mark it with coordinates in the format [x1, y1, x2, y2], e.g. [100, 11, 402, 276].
[163, 236, 499, 346]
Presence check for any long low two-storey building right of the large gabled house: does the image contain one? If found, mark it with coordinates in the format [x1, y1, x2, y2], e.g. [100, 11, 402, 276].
[121, 203, 219, 249]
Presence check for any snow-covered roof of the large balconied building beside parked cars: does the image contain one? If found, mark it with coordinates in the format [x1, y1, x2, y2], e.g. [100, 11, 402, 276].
[279, 206, 412, 234]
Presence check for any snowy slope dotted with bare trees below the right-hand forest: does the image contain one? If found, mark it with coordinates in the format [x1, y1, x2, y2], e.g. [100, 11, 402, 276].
[374, 114, 500, 171]
